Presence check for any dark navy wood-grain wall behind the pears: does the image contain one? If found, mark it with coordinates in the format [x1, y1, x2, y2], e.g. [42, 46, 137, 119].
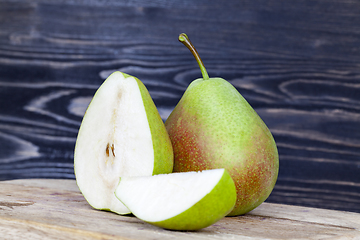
[0, 0, 360, 212]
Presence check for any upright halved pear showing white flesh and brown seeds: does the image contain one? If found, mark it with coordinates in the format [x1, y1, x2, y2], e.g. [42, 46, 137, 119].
[74, 71, 173, 214]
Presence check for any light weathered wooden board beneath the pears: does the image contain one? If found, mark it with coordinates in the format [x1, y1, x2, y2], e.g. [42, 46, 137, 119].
[0, 179, 360, 240]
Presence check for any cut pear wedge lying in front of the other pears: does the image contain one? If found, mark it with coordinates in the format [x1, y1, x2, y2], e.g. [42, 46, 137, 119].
[115, 169, 236, 230]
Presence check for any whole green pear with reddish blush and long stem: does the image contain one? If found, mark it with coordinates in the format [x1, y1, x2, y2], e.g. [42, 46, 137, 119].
[165, 34, 279, 216]
